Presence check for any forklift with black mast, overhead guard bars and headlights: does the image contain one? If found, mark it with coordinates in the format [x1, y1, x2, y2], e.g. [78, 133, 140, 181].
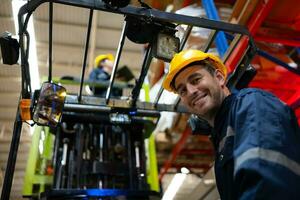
[0, 0, 256, 200]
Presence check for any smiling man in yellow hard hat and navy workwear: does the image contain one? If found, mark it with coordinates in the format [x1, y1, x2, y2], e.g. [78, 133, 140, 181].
[163, 50, 300, 200]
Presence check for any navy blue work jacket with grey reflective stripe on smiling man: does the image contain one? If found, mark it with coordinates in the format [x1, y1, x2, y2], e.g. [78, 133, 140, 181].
[212, 88, 300, 200]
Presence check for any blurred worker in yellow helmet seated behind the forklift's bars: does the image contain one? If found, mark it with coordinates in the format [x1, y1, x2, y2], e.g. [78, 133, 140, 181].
[89, 54, 122, 97]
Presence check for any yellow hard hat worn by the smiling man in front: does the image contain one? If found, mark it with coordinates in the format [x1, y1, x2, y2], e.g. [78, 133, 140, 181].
[163, 49, 227, 92]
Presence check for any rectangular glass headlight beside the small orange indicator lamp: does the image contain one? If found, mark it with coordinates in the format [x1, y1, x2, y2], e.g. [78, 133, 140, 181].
[33, 83, 67, 127]
